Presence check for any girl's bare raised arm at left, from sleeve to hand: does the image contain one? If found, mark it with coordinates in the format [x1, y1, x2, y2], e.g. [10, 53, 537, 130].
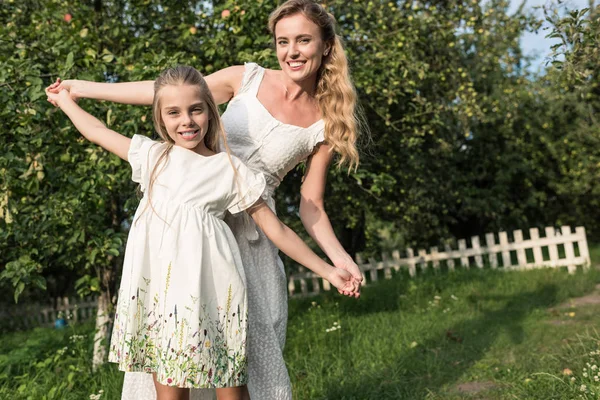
[46, 89, 131, 161]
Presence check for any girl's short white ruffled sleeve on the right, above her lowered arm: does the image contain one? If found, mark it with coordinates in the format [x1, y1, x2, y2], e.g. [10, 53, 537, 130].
[227, 160, 267, 214]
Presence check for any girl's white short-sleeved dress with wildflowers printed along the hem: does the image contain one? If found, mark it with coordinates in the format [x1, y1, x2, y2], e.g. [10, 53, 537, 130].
[109, 135, 265, 388]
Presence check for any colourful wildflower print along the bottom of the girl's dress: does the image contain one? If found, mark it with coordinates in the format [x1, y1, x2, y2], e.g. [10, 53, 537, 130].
[109, 274, 248, 388]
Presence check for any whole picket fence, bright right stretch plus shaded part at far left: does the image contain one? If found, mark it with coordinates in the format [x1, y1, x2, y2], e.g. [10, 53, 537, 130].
[0, 226, 590, 330]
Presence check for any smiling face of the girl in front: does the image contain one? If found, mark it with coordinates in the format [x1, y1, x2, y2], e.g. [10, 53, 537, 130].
[160, 85, 210, 155]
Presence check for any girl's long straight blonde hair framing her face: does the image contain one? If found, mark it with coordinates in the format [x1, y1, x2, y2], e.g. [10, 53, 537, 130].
[140, 65, 236, 217]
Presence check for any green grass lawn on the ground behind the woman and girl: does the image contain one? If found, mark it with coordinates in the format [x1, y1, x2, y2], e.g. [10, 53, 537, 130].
[0, 269, 600, 400]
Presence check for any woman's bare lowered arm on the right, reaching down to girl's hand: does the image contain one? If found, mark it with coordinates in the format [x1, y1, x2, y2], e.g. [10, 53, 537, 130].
[300, 144, 362, 283]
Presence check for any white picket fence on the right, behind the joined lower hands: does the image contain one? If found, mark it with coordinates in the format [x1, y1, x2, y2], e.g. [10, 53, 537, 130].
[288, 226, 590, 297]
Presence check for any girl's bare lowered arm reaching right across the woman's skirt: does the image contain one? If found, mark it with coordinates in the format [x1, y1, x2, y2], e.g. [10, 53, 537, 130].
[248, 200, 359, 297]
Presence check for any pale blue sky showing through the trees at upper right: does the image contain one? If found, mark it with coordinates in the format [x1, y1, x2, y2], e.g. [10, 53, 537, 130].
[509, 0, 598, 71]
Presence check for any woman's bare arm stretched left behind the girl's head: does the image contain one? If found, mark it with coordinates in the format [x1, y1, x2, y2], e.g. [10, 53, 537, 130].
[47, 65, 245, 105]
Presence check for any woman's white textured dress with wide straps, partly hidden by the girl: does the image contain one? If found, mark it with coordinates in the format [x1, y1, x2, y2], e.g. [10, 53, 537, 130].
[122, 63, 325, 400]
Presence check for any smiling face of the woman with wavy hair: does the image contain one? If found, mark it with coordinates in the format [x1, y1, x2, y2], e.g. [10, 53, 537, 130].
[275, 14, 330, 82]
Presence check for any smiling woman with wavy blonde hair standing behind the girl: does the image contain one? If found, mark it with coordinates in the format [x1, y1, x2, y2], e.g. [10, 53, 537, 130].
[47, 0, 362, 400]
